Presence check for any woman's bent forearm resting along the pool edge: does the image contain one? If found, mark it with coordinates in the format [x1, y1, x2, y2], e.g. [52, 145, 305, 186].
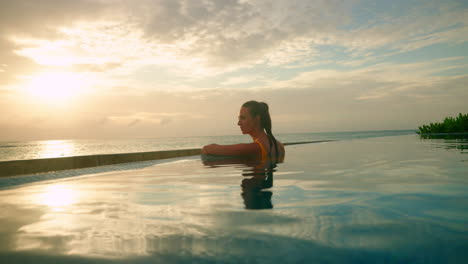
[202, 143, 261, 156]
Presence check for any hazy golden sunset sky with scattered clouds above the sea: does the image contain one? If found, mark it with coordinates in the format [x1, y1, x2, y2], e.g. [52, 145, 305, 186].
[0, 0, 468, 141]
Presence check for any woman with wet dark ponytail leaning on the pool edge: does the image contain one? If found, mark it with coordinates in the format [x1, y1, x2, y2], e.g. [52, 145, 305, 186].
[202, 101, 285, 162]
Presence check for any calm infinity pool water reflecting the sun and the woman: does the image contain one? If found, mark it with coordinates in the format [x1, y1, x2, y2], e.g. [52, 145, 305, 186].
[0, 135, 468, 263]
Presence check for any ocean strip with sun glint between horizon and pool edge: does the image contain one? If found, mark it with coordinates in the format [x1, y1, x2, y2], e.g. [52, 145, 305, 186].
[0, 130, 415, 161]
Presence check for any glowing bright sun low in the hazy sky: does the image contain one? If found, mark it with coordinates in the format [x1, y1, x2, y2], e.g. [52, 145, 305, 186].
[25, 72, 85, 105]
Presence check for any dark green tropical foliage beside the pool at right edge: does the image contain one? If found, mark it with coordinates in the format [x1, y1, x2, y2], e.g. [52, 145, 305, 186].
[417, 113, 468, 134]
